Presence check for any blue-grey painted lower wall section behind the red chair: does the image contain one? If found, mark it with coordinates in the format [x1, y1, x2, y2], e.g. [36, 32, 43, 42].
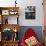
[19, 26, 43, 43]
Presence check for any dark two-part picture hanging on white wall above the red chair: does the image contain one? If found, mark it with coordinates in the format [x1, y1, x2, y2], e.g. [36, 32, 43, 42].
[25, 6, 36, 19]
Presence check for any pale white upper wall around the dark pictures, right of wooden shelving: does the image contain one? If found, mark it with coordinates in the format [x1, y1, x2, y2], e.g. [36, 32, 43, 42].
[19, 0, 43, 26]
